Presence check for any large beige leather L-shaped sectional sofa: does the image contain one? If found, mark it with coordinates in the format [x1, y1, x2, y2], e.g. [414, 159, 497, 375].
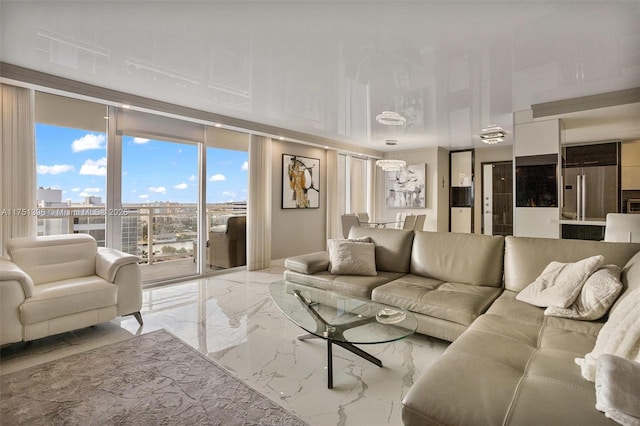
[284, 228, 640, 425]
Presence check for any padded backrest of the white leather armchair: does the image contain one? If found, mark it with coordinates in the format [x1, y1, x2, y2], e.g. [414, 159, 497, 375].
[6, 234, 98, 285]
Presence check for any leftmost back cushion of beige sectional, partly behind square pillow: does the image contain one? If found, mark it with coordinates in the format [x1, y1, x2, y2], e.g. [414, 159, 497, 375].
[349, 226, 413, 274]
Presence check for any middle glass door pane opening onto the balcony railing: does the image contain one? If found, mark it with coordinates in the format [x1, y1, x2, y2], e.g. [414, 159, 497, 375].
[121, 134, 198, 283]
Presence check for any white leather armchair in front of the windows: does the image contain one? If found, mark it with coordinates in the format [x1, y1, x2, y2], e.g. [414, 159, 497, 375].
[0, 234, 142, 345]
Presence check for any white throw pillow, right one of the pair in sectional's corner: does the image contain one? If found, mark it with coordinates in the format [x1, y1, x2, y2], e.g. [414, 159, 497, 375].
[544, 265, 622, 321]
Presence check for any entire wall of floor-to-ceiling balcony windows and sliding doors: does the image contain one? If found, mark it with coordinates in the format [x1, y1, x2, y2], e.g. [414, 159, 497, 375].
[36, 92, 248, 283]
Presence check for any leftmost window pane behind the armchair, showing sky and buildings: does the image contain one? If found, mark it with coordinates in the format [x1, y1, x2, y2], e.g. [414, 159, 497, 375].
[35, 92, 107, 246]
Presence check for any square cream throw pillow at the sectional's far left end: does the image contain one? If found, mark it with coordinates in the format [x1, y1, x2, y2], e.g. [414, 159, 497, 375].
[328, 240, 378, 276]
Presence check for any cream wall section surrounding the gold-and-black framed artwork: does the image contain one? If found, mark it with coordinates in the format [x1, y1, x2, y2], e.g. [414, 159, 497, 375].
[271, 141, 327, 260]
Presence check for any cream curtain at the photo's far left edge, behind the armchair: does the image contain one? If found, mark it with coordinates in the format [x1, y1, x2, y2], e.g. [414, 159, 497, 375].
[0, 84, 37, 256]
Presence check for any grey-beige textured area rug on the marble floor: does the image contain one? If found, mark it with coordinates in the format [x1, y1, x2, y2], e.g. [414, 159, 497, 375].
[0, 330, 305, 426]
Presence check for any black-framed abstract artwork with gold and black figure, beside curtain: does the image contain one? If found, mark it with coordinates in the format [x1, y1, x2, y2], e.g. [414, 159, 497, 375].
[282, 154, 320, 209]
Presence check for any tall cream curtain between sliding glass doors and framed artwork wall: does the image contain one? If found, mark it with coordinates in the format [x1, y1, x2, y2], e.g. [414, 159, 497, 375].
[247, 135, 273, 271]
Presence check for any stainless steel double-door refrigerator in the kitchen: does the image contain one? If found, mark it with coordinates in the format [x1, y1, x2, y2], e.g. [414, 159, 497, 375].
[562, 165, 620, 220]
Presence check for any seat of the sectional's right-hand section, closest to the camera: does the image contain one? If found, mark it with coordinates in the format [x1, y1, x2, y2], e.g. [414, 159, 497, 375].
[402, 300, 611, 425]
